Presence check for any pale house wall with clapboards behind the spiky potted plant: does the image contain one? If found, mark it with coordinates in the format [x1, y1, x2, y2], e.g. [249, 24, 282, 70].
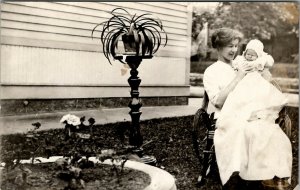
[0, 2, 191, 114]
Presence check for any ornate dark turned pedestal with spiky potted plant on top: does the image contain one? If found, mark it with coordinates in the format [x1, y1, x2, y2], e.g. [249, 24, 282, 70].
[92, 8, 168, 165]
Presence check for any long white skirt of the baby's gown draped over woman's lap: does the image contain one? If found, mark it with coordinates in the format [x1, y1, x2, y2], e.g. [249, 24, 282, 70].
[219, 71, 287, 123]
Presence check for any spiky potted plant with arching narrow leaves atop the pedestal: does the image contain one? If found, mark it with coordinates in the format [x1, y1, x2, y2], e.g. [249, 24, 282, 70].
[92, 8, 168, 64]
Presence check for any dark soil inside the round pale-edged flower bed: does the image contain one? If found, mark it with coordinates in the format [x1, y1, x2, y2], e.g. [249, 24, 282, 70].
[1, 163, 150, 190]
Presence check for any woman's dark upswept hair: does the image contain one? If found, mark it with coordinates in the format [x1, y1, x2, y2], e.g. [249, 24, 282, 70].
[211, 28, 243, 48]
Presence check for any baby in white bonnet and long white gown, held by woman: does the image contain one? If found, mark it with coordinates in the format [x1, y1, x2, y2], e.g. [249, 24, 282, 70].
[220, 40, 287, 121]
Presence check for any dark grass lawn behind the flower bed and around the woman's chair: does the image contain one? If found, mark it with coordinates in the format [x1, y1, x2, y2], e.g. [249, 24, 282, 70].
[1, 108, 298, 190]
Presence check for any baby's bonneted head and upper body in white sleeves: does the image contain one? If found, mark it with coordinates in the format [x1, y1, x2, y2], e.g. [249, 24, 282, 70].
[232, 39, 274, 81]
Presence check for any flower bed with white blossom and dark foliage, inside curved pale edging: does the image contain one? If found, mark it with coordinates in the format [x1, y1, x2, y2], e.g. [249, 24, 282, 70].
[0, 114, 151, 190]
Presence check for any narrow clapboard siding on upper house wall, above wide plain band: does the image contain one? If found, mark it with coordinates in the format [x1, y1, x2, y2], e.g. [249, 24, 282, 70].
[1, 2, 188, 53]
